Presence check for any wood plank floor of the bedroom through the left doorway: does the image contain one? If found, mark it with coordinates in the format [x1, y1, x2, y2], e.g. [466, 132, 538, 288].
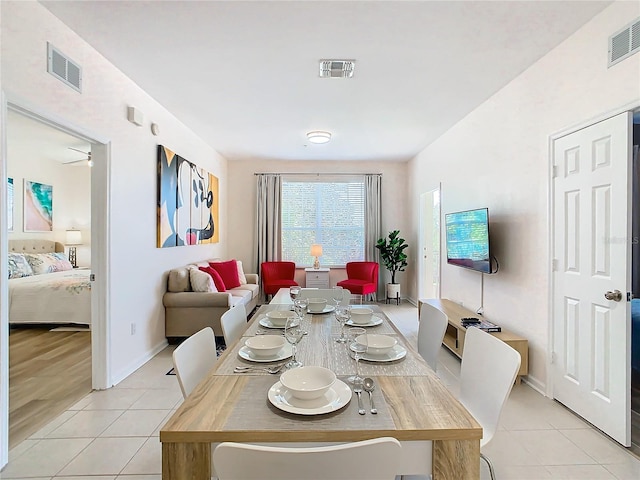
[9, 326, 91, 448]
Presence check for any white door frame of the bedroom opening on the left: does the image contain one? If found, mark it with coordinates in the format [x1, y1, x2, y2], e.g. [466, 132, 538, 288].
[0, 91, 112, 468]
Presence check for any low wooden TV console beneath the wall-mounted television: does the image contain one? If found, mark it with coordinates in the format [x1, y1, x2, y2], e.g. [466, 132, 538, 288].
[418, 298, 529, 384]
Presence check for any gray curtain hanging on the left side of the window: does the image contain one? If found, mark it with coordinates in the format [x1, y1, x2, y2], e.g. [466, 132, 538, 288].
[255, 173, 282, 272]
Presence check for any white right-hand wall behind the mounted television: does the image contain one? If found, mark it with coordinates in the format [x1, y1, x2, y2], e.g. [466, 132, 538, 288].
[409, 2, 640, 389]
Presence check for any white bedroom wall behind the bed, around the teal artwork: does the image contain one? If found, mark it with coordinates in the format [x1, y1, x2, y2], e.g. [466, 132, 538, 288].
[7, 122, 91, 266]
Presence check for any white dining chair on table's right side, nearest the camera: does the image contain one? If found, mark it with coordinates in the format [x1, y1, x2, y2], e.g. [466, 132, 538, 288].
[459, 327, 521, 480]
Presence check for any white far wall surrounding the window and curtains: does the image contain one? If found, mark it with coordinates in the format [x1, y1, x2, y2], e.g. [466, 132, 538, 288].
[228, 160, 410, 290]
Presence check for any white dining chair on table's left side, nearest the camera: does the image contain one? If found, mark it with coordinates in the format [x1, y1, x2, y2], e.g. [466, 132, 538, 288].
[173, 327, 218, 398]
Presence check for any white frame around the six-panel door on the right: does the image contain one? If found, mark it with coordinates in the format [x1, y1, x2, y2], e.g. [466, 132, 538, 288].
[544, 100, 640, 398]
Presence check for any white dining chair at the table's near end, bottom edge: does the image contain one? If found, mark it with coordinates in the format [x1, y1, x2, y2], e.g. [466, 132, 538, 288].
[213, 437, 402, 480]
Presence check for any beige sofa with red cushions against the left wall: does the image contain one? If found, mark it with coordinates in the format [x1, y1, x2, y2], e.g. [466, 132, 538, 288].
[162, 259, 260, 339]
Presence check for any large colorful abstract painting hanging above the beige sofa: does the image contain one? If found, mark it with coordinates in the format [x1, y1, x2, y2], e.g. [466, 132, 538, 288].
[157, 145, 220, 248]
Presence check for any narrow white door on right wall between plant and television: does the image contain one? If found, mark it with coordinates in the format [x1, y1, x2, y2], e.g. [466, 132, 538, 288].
[418, 188, 440, 298]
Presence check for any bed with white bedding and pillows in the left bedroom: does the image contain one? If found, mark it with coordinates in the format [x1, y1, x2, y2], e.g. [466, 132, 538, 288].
[8, 240, 91, 325]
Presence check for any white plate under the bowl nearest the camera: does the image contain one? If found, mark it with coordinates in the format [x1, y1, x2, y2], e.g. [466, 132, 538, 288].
[268, 380, 352, 415]
